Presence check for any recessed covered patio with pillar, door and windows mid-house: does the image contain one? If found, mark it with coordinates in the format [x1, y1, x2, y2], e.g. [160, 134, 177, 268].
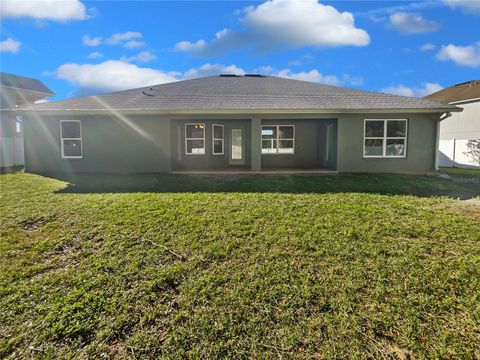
[170, 116, 337, 174]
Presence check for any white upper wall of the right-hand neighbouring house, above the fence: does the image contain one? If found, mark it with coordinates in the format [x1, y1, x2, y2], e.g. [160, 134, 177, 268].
[440, 100, 480, 140]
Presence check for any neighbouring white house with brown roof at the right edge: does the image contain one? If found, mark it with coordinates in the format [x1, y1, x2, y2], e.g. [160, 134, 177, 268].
[425, 80, 480, 169]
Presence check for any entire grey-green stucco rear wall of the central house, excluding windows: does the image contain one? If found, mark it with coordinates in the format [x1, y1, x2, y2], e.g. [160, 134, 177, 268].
[24, 113, 440, 174]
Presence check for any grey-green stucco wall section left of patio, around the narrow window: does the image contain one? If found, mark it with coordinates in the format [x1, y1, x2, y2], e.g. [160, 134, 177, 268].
[24, 115, 170, 173]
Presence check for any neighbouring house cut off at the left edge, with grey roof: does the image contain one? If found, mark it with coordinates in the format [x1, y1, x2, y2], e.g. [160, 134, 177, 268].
[0, 72, 53, 168]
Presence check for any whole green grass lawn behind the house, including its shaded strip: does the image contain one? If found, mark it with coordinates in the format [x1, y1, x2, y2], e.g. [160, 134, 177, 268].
[0, 173, 480, 359]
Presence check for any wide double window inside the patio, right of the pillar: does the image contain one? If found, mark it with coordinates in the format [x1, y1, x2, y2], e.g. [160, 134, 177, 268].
[262, 125, 295, 154]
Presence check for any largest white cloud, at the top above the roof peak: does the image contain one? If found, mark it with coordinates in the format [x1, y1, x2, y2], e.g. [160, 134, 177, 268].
[175, 0, 370, 56]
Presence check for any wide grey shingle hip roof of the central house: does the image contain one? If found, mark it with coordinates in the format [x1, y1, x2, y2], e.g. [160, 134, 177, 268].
[15, 76, 455, 112]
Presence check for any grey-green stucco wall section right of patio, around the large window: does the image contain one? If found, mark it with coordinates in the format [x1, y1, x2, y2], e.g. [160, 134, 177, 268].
[337, 114, 439, 174]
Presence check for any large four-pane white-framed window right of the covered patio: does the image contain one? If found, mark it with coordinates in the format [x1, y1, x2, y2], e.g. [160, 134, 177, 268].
[363, 119, 407, 157]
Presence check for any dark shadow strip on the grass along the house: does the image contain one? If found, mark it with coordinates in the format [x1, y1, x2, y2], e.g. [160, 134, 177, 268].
[48, 174, 480, 199]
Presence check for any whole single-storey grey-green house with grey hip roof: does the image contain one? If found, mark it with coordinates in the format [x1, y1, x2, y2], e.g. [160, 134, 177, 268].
[10, 74, 461, 174]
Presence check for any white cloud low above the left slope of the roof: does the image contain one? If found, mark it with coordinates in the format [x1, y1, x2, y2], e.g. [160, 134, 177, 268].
[53, 60, 178, 92]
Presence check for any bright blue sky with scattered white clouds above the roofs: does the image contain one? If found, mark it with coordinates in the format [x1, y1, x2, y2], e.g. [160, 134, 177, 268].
[0, 0, 480, 100]
